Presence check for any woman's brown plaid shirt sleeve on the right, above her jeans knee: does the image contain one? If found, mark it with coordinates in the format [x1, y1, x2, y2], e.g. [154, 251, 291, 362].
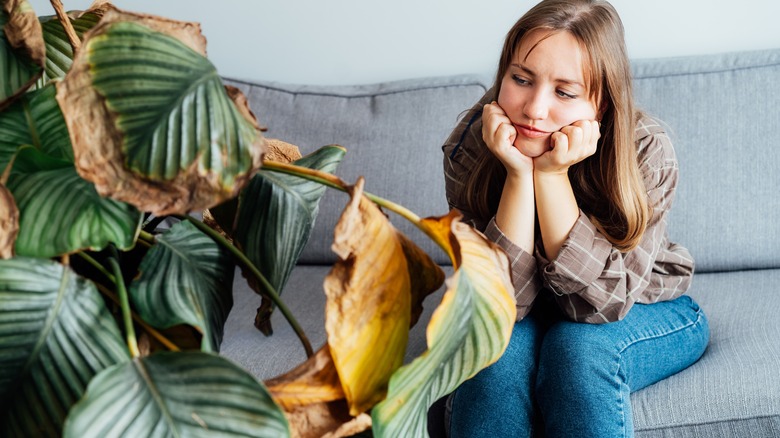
[535, 122, 693, 323]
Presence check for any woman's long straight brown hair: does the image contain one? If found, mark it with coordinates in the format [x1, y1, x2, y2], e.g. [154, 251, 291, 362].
[466, 0, 651, 251]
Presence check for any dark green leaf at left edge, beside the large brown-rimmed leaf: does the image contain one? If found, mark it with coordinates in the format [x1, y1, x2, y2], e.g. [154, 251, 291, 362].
[0, 85, 73, 171]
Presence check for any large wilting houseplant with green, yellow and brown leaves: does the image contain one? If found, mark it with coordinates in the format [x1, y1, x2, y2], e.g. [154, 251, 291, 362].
[0, 0, 514, 436]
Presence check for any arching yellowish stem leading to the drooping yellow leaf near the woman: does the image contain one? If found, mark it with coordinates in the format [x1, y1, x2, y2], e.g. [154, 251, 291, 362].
[262, 161, 453, 258]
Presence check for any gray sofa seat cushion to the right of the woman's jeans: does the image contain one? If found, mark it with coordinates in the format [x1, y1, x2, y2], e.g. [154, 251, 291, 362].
[631, 269, 780, 438]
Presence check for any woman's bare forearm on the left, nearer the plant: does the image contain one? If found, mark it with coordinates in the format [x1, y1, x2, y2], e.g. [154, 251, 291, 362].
[496, 173, 535, 254]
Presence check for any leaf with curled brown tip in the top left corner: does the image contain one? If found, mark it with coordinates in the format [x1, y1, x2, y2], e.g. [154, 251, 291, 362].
[0, 0, 46, 110]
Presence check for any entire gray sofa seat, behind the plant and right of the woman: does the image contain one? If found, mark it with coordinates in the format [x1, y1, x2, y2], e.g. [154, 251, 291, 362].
[221, 265, 780, 438]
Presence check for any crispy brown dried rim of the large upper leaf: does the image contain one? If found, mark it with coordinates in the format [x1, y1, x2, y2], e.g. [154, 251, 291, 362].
[57, 5, 265, 216]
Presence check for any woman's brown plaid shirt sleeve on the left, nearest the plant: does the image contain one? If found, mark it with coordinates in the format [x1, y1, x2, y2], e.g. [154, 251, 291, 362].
[442, 90, 541, 321]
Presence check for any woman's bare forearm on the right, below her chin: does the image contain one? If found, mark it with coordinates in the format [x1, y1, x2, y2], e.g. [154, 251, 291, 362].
[534, 171, 580, 260]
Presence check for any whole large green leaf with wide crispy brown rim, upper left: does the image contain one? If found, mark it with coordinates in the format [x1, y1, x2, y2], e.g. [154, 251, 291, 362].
[57, 6, 265, 216]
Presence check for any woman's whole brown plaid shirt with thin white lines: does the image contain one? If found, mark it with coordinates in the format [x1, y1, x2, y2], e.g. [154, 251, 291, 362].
[442, 90, 694, 323]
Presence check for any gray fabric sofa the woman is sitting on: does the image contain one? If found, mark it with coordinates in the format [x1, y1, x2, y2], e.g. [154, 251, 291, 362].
[221, 49, 780, 438]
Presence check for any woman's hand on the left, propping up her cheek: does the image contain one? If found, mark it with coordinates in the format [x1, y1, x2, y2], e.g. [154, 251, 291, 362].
[482, 101, 534, 175]
